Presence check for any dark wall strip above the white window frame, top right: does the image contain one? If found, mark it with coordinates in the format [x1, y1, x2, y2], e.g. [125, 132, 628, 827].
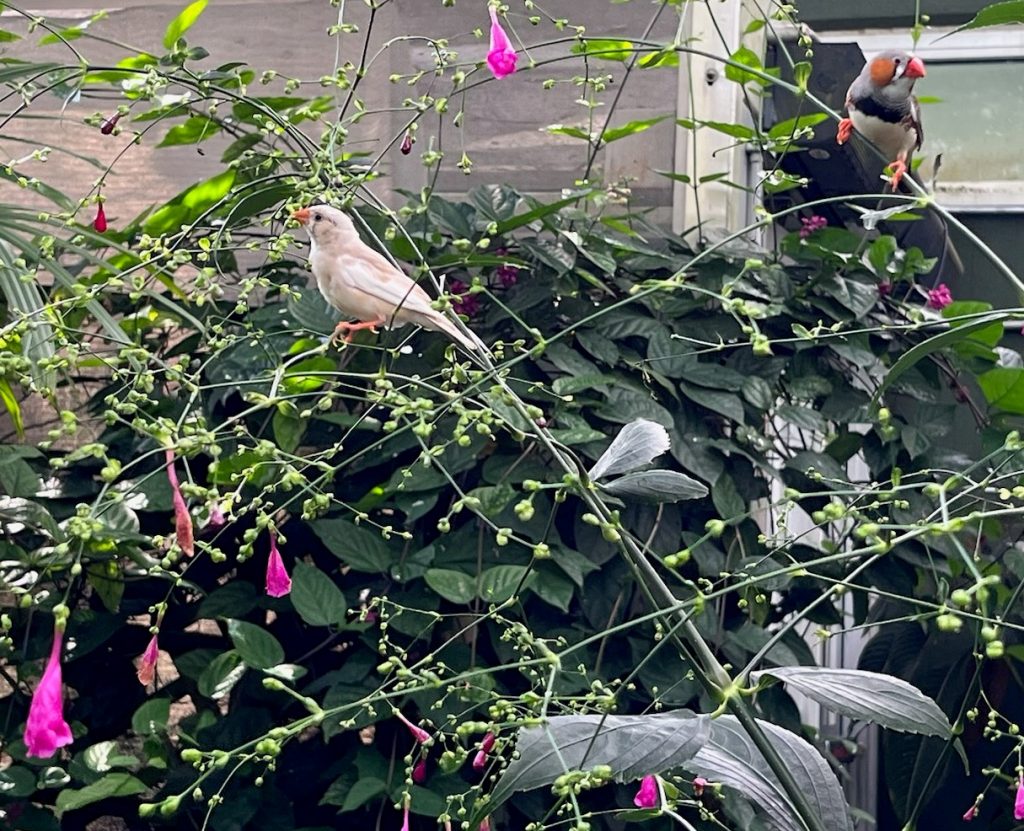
[797, 0, 974, 30]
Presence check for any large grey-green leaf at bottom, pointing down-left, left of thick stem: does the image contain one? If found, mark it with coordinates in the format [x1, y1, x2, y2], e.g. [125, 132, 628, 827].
[481, 710, 711, 814]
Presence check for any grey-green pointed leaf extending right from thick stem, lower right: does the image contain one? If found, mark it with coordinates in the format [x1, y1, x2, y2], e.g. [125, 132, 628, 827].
[751, 666, 952, 738]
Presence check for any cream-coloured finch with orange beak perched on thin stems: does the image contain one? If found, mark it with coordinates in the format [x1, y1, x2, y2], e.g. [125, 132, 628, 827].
[292, 205, 485, 352]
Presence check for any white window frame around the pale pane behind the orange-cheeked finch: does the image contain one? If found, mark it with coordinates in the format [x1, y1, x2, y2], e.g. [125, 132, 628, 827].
[816, 26, 1024, 213]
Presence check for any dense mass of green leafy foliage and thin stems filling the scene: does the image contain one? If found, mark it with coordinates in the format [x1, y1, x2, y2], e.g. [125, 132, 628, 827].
[0, 0, 1024, 829]
